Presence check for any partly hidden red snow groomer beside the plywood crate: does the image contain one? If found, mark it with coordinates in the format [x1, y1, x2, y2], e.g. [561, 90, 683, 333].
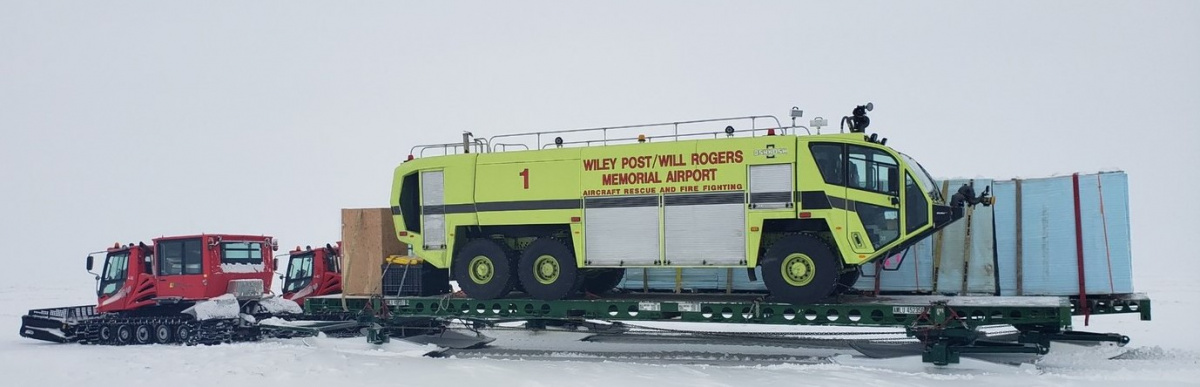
[280, 242, 342, 305]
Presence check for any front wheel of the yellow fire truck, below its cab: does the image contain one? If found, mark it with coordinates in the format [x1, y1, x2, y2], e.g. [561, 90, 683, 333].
[761, 234, 841, 304]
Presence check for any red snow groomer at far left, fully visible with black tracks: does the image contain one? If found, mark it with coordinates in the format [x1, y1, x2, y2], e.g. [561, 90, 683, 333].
[20, 234, 302, 345]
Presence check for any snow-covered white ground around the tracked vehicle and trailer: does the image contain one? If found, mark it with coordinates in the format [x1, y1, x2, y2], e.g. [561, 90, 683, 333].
[0, 276, 1200, 387]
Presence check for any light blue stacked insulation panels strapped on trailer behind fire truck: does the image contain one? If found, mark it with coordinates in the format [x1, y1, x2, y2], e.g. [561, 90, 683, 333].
[620, 172, 1133, 296]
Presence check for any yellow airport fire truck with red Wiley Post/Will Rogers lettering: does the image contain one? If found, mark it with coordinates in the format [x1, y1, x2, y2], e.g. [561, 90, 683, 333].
[391, 105, 990, 303]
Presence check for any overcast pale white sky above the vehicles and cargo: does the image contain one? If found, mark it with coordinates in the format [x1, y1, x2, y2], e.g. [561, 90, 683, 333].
[0, 0, 1200, 287]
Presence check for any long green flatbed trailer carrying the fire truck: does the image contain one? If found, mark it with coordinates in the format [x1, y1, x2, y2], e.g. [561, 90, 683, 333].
[305, 293, 1151, 365]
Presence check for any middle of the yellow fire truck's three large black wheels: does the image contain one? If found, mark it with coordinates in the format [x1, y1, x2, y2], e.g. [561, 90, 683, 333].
[517, 238, 583, 300]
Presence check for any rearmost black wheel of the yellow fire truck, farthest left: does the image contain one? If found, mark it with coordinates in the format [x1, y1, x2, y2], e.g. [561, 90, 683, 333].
[451, 239, 517, 299]
